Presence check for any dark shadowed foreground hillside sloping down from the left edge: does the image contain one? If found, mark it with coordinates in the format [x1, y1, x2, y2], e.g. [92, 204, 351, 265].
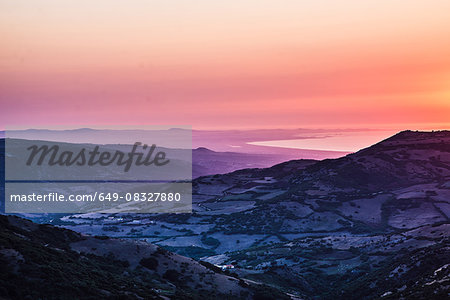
[0, 215, 288, 299]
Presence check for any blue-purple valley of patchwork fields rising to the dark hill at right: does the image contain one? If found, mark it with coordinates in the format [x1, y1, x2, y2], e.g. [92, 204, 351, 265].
[1, 131, 450, 299]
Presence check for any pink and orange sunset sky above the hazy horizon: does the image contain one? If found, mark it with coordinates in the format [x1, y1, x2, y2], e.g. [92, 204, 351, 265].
[0, 0, 450, 130]
